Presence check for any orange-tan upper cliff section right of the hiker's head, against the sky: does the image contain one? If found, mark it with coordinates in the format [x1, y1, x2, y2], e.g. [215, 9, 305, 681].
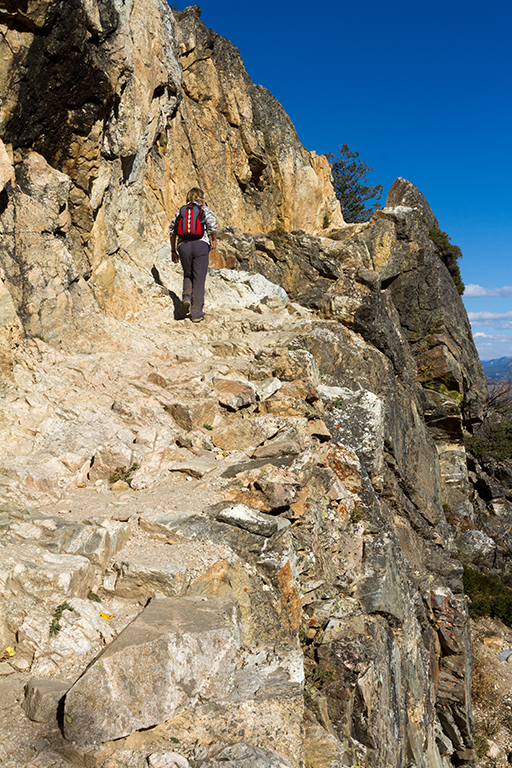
[169, 6, 343, 232]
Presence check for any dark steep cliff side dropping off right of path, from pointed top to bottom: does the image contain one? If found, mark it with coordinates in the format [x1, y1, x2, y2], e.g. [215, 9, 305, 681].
[215, 186, 492, 764]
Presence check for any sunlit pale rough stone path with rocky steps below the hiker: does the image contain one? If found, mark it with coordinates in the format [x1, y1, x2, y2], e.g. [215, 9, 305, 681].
[0, 265, 362, 768]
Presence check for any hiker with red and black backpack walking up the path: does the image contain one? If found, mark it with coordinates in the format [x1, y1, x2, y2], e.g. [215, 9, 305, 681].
[170, 187, 217, 323]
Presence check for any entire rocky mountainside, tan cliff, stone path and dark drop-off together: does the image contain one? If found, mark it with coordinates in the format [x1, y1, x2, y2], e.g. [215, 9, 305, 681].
[0, 0, 494, 768]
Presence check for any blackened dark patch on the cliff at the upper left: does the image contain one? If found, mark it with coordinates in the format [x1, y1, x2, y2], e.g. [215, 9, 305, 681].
[4, 0, 118, 160]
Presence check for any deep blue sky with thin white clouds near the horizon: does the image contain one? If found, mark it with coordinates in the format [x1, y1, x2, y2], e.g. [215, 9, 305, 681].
[175, 0, 512, 360]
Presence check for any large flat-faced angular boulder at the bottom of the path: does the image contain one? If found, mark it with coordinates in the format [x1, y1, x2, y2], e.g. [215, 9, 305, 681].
[63, 597, 240, 744]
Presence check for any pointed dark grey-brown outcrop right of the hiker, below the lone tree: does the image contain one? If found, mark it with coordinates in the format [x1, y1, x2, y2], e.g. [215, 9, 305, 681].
[221, 195, 487, 428]
